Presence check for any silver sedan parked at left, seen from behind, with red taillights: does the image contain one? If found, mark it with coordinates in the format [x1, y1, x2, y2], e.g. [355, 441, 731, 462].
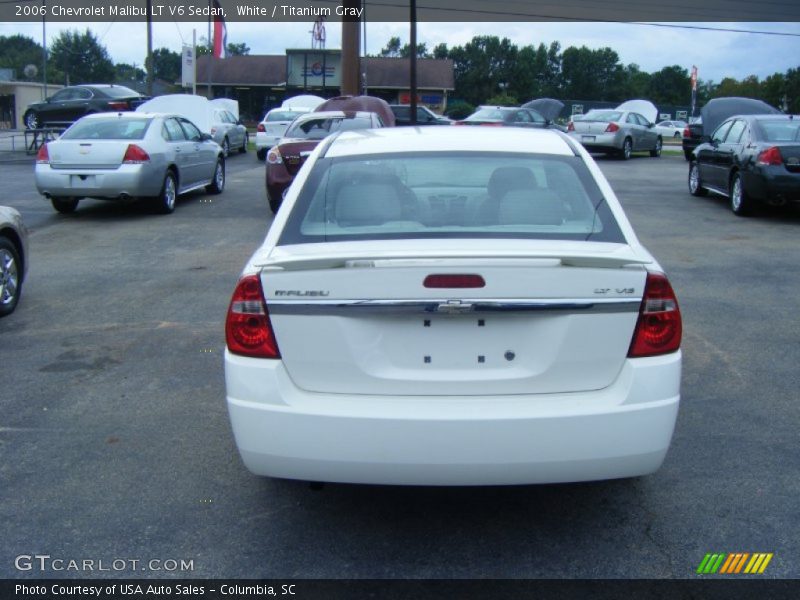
[35, 112, 225, 213]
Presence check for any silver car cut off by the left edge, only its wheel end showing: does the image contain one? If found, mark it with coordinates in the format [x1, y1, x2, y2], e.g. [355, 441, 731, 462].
[0, 206, 28, 317]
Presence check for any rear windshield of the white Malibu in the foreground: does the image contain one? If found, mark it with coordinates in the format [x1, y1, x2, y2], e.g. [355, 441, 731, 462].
[279, 152, 625, 245]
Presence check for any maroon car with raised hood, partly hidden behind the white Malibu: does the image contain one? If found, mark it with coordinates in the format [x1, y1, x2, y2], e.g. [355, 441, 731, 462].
[267, 111, 384, 213]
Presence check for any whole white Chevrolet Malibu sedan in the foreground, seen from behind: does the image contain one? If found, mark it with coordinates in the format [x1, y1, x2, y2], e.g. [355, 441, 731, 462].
[225, 127, 681, 485]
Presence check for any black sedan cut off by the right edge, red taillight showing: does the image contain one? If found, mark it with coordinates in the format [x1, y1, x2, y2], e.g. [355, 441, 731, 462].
[689, 114, 800, 215]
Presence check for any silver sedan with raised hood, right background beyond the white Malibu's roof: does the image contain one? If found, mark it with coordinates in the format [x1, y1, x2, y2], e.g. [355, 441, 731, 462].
[567, 109, 663, 160]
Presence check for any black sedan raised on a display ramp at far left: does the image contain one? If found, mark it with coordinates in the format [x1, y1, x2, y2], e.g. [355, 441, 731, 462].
[22, 84, 148, 129]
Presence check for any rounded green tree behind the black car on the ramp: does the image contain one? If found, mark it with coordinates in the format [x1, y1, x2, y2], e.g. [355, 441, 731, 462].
[50, 29, 115, 85]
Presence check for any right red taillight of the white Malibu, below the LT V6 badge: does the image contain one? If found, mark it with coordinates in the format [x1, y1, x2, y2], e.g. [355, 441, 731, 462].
[628, 273, 682, 358]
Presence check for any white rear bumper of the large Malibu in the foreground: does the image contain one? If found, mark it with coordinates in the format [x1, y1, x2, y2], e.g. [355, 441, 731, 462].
[225, 351, 681, 485]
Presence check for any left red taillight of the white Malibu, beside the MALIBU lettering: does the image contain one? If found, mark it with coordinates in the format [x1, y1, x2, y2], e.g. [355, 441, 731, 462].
[225, 275, 281, 358]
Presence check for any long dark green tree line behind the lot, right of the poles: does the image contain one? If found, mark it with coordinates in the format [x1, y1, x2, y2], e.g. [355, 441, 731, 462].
[378, 36, 800, 113]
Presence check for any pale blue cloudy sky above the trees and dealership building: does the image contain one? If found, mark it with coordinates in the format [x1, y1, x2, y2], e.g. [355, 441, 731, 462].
[0, 22, 800, 82]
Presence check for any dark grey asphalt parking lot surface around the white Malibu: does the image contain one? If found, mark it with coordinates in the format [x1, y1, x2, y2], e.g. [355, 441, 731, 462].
[0, 148, 800, 579]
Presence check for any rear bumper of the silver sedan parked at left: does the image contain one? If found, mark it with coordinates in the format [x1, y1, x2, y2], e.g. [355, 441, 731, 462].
[35, 164, 165, 199]
